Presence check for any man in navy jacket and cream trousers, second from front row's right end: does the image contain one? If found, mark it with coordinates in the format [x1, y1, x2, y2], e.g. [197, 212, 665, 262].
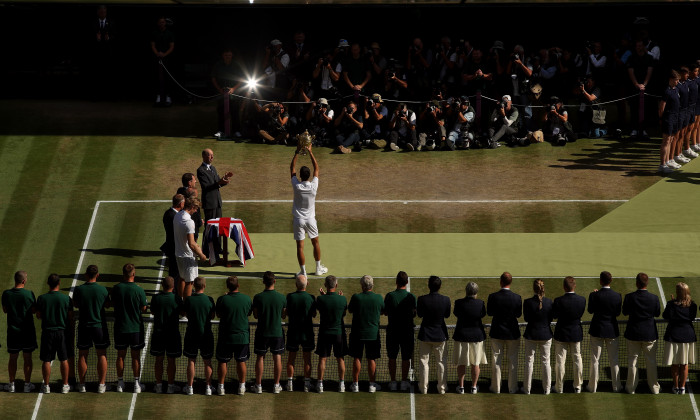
[622, 273, 661, 394]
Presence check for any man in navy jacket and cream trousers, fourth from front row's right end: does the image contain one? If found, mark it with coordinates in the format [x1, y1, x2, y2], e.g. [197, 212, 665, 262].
[552, 276, 586, 394]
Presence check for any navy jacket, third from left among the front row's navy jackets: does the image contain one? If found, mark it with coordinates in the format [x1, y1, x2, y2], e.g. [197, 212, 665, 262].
[486, 289, 523, 340]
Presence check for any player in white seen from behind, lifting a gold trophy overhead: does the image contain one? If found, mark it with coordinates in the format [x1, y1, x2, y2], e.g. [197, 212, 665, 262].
[290, 145, 328, 276]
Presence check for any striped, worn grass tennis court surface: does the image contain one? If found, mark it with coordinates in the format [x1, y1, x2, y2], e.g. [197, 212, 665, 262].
[0, 100, 700, 419]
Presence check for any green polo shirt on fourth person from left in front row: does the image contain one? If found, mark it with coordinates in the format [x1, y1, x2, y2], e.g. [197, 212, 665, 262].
[110, 282, 148, 334]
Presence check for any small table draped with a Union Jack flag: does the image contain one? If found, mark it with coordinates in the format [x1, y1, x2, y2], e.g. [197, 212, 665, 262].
[202, 217, 255, 266]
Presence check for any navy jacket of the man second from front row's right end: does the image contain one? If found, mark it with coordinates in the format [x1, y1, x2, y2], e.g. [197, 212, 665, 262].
[622, 289, 661, 341]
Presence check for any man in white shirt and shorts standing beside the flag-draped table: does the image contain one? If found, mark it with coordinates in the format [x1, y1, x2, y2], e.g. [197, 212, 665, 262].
[173, 198, 207, 299]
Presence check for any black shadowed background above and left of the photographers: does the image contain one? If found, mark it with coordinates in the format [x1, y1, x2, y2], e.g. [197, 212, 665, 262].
[0, 3, 700, 100]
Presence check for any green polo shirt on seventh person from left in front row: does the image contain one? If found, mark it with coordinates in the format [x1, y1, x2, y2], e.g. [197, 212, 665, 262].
[216, 292, 253, 344]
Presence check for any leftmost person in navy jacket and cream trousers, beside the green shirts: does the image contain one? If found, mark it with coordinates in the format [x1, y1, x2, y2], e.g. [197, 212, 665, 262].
[416, 276, 452, 394]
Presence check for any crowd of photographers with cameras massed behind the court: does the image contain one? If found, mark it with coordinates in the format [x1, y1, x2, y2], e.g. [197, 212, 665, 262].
[212, 20, 661, 153]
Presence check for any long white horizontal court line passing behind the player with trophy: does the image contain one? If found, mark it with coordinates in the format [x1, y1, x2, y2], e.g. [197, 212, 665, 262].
[98, 199, 629, 204]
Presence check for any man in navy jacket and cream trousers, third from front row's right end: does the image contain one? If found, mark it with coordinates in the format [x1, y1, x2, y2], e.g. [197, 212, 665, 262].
[586, 271, 622, 392]
